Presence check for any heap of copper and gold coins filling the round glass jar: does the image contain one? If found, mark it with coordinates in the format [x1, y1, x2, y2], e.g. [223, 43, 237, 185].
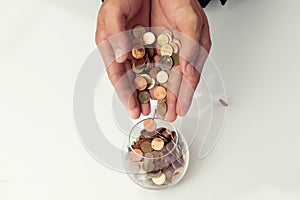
[125, 118, 188, 188]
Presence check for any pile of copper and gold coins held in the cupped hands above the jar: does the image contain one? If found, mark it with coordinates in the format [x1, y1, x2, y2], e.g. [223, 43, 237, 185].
[131, 25, 181, 116]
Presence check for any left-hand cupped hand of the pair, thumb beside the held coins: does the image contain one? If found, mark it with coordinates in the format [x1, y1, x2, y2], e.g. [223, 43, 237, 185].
[95, 0, 150, 119]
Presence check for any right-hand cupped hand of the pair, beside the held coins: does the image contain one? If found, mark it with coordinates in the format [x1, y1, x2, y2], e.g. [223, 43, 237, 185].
[151, 0, 211, 121]
